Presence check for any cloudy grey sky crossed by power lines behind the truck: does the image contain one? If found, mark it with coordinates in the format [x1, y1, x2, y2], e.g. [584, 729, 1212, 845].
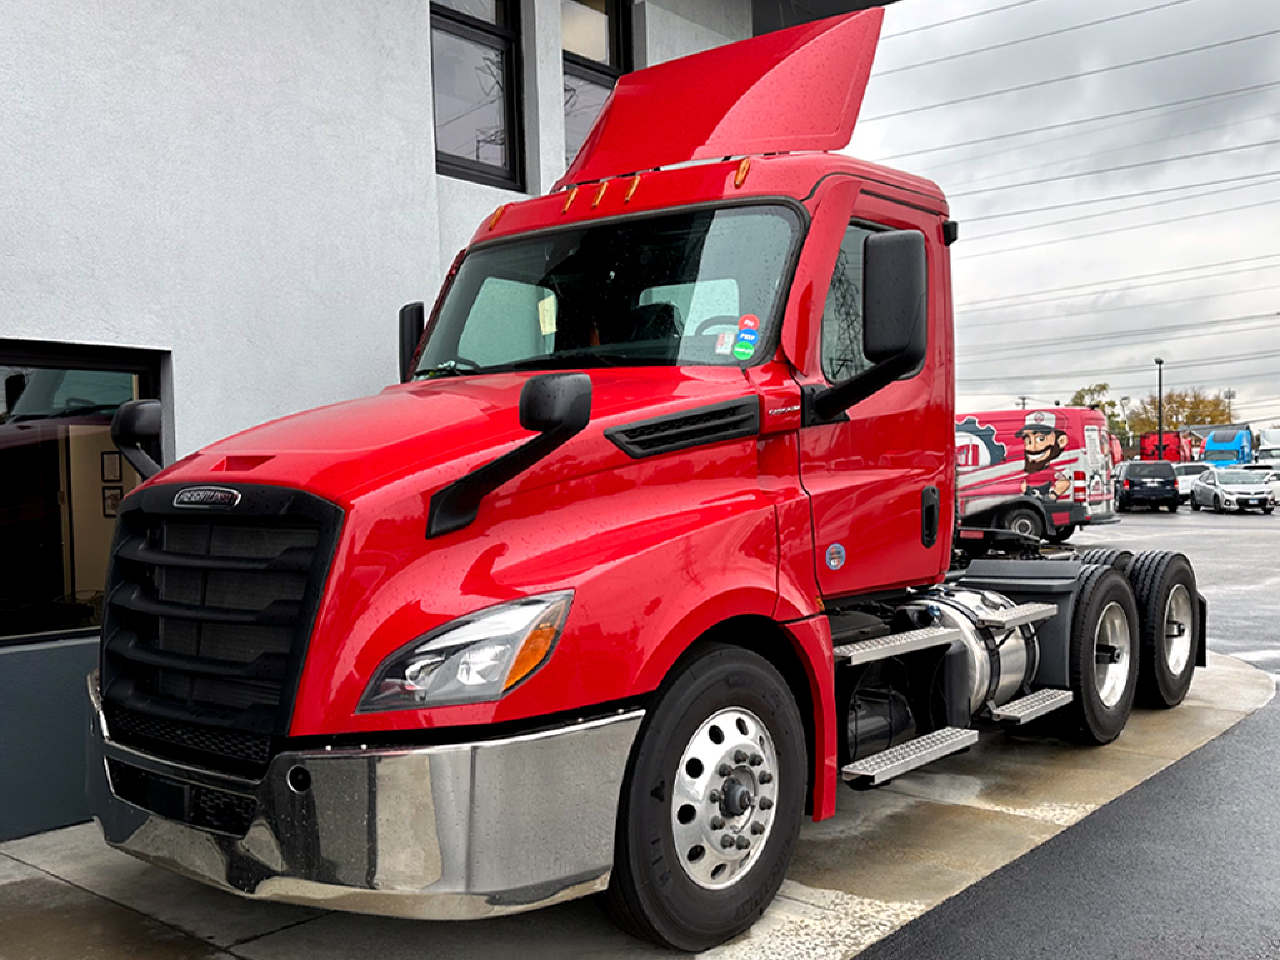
[849, 0, 1280, 425]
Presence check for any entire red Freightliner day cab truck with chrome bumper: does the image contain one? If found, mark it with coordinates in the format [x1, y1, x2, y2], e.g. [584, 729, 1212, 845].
[88, 10, 1204, 950]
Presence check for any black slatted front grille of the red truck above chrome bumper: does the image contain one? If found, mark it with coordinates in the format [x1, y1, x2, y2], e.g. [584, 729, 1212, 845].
[102, 484, 342, 776]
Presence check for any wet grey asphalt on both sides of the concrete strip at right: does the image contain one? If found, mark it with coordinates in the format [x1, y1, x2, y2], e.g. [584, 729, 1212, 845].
[858, 507, 1280, 960]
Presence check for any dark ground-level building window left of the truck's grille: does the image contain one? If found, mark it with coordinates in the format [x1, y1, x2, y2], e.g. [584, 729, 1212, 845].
[0, 340, 160, 645]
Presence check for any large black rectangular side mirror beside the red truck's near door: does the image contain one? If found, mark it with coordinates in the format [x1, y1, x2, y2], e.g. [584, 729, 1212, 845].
[805, 230, 929, 422]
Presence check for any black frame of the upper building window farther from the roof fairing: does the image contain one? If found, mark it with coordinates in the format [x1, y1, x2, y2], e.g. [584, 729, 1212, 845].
[430, 0, 526, 192]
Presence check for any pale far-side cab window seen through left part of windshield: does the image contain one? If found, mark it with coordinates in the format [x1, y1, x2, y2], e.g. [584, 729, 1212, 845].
[458, 276, 557, 366]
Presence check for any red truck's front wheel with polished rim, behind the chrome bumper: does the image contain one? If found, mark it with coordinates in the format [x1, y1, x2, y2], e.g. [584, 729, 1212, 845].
[604, 644, 808, 951]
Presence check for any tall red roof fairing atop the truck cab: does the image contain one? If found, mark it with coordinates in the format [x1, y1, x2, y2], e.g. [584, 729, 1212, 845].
[557, 8, 884, 187]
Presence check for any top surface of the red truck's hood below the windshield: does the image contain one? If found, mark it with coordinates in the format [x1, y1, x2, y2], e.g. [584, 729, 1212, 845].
[156, 367, 750, 506]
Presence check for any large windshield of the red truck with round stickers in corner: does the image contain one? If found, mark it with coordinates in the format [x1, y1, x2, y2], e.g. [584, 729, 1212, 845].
[415, 204, 800, 378]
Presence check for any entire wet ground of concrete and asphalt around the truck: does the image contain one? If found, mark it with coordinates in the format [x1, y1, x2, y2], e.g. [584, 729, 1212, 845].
[0, 508, 1280, 960]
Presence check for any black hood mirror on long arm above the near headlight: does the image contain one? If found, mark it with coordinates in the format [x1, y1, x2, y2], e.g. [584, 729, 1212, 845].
[426, 374, 591, 540]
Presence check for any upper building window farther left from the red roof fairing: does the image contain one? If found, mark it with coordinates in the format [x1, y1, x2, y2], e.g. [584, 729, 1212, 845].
[431, 0, 524, 189]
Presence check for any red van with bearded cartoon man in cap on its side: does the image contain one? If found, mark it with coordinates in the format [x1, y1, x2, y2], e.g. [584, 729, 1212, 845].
[956, 407, 1116, 543]
